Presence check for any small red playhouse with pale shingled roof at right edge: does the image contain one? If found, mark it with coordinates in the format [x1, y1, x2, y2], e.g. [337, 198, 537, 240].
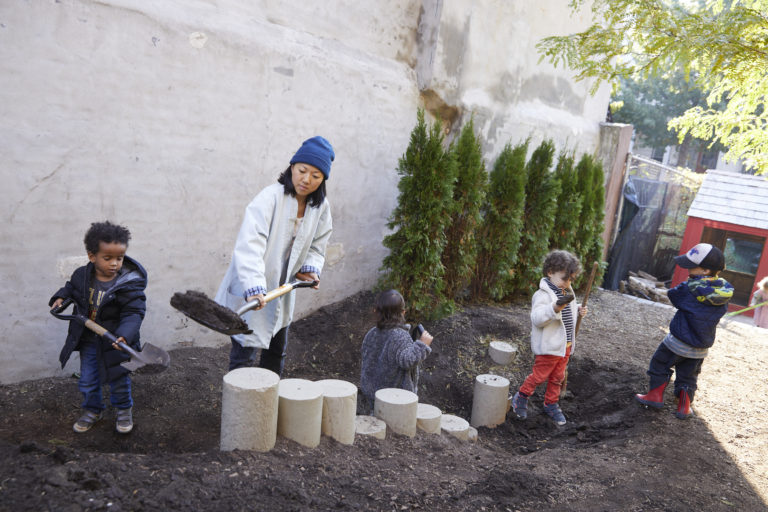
[672, 170, 768, 315]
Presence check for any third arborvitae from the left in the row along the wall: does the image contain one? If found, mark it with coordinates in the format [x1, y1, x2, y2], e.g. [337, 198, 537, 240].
[472, 141, 528, 300]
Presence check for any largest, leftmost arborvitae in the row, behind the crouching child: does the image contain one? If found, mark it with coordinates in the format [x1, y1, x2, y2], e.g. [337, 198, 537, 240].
[379, 109, 456, 320]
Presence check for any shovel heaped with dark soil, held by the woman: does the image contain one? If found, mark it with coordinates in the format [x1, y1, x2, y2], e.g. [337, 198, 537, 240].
[171, 280, 318, 336]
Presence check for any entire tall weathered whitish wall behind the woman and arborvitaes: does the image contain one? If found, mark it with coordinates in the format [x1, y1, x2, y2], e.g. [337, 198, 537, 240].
[0, 0, 608, 382]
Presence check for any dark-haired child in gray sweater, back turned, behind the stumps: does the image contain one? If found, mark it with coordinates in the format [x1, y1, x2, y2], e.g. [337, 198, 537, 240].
[360, 290, 432, 413]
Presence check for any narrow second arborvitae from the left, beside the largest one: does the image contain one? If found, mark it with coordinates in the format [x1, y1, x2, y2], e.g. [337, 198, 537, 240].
[443, 120, 488, 299]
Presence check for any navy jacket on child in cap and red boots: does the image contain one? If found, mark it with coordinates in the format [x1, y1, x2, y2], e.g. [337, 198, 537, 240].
[667, 276, 733, 348]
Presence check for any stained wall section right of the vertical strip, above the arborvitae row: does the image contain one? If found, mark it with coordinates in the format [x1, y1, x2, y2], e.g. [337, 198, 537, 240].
[423, 0, 610, 156]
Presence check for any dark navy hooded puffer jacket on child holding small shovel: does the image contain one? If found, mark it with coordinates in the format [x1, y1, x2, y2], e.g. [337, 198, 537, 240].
[48, 256, 147, 382]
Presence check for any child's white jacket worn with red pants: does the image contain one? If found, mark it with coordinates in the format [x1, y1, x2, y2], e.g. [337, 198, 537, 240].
[531, 278, 579, 357]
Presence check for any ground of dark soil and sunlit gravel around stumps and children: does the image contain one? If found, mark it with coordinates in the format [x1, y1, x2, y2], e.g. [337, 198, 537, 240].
[0, 291, 768, 511]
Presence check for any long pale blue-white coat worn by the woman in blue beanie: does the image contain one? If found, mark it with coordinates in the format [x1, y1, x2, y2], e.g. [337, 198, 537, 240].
[215, 183, 332, 348]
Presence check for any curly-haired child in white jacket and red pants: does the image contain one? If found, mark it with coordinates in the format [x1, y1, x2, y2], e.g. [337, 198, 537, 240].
[512, 250, 587, 426]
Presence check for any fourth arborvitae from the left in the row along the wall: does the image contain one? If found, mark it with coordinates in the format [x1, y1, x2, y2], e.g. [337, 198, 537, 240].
[512, 140, 560, 294]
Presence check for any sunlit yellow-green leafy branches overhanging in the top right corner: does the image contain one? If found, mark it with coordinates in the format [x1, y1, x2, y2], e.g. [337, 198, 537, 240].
[537, 0, 768, 173]
